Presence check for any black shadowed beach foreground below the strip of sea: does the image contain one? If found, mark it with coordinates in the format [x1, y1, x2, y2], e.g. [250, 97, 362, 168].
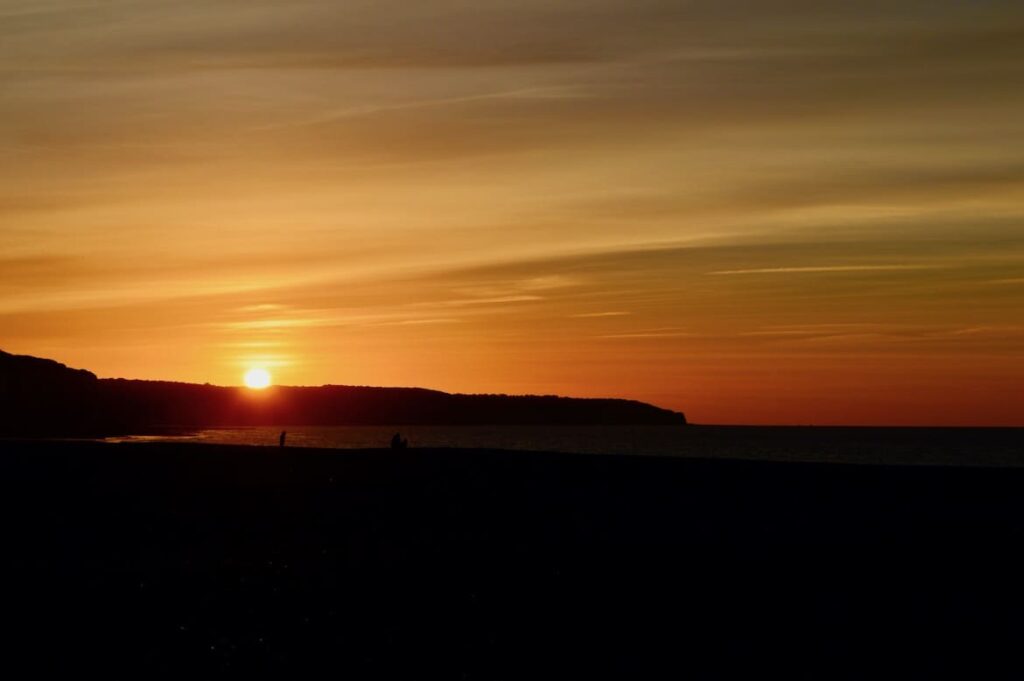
[0, 441, 1024, 679]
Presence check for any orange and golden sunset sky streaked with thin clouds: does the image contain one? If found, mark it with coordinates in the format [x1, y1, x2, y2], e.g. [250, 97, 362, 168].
[0, 0, 1024, 425]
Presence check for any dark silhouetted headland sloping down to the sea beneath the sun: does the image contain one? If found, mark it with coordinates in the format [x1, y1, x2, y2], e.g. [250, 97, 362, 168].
[0, 350, 686, 435]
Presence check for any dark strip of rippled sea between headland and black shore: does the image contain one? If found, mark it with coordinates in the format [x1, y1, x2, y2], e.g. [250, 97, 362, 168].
[106, 425, 1024, 466]
